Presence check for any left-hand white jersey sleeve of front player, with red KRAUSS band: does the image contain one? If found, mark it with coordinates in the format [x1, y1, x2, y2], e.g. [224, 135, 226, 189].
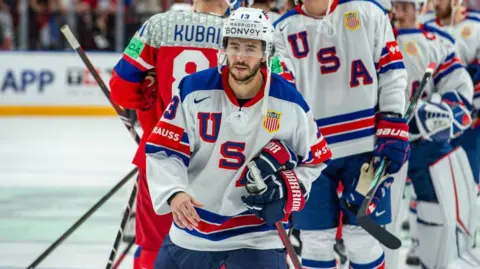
[145, 85, 194, 215]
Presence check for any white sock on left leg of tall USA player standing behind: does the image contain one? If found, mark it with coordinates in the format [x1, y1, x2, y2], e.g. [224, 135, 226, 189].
[300, 228, 337, 268]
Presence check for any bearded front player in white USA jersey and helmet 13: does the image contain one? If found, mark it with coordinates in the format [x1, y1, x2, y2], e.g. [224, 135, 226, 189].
[146, 8, 331, 269]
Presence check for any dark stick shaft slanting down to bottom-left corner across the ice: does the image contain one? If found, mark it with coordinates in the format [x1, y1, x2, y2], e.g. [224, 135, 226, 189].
[27, 168, 138, 269]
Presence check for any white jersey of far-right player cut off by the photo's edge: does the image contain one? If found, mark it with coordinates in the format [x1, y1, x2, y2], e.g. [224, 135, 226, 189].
[425, 13, 480, 110]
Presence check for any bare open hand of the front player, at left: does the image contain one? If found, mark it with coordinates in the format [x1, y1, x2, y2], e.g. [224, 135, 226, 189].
[170, 192, 203, 230]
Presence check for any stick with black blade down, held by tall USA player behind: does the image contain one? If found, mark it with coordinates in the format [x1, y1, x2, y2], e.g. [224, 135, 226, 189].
[356, 63, 436, 249]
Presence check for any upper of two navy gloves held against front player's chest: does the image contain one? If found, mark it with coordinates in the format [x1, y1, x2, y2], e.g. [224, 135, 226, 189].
[241, 140, 298, 182]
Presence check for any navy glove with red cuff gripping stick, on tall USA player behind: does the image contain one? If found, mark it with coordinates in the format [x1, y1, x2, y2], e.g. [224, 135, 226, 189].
[373, 116, 410, 174]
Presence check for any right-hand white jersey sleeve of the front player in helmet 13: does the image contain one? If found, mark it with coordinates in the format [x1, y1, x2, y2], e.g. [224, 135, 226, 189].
[289, 103, 332, 193]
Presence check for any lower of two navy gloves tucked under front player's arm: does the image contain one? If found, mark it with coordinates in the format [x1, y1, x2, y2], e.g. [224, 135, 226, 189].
[242, 170, 306, 225]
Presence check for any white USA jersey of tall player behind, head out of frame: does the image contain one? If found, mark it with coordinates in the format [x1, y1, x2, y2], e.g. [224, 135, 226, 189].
[274, 0, 407, 158]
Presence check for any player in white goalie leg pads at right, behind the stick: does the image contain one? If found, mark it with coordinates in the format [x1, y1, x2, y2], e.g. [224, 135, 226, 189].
[392, 0, 480, 269]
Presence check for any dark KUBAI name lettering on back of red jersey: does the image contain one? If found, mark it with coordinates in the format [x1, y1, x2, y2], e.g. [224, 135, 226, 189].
[173, 24, 222, 44]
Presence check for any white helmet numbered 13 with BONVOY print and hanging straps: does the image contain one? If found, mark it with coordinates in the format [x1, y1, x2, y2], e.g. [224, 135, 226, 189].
[218, 7, 275, 114]
